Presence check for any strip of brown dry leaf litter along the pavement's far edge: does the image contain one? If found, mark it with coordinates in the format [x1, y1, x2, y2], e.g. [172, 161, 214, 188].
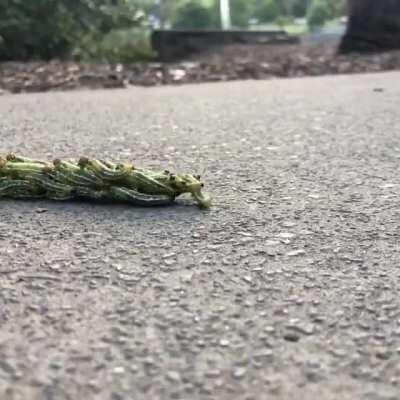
[0, 44, 400, 94]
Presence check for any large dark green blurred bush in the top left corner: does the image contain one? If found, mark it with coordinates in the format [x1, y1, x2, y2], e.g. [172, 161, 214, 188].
[0, 0, 142, 60]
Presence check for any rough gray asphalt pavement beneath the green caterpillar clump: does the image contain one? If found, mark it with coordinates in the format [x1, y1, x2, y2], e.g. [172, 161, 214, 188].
[0, 73, 400, 400]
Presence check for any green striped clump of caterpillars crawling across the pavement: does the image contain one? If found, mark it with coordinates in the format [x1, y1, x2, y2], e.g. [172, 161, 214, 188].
[0, 154, 211, 208]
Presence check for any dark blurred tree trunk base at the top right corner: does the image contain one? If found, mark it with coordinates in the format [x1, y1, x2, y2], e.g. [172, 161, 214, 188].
[339, 0, 400, 53]
